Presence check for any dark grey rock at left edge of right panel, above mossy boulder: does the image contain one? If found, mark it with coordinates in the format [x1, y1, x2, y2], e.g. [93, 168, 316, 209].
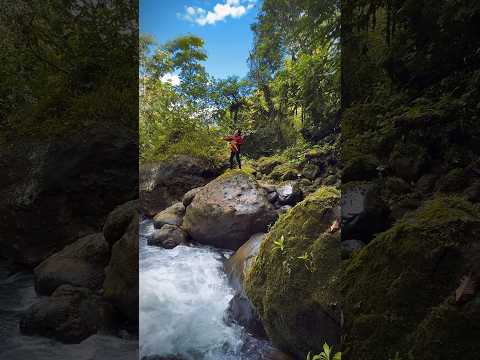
[341, 183, 389, 243]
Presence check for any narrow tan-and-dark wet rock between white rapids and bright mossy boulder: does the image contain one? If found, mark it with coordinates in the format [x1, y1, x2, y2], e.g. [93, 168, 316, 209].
[225, 233, 266, 337]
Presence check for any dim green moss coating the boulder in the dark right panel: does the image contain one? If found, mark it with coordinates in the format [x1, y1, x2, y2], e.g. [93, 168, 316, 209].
[339, 196, 480, 360]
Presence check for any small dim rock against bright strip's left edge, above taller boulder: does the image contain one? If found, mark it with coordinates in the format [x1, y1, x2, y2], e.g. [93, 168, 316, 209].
[103, 199, 138, 246]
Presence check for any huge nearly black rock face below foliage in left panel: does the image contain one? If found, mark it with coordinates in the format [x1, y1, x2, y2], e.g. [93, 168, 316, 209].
[0, 126, 138, 266]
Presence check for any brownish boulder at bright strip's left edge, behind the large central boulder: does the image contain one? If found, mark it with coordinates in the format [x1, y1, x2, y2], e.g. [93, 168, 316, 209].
[140, 155, 220, 216]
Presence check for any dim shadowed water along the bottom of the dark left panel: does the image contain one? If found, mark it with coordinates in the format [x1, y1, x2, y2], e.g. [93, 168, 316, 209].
[0, 264, 138, 360]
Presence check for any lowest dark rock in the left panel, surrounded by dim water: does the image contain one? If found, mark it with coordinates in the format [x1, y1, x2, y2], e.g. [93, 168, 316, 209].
[20, 285, 113, 343]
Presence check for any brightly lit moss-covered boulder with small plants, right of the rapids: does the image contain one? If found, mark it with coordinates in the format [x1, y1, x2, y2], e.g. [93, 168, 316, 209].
[244, 187, 341, 358]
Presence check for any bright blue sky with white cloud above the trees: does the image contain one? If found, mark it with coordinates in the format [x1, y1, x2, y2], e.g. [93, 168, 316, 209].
[140, 0, 261, 78]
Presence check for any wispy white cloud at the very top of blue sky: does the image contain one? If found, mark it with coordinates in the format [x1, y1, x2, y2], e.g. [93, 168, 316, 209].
[178, 0, 256, 26]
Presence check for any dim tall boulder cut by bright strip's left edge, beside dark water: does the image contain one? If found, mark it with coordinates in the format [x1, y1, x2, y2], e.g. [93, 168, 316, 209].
[103, 215, 139, 325]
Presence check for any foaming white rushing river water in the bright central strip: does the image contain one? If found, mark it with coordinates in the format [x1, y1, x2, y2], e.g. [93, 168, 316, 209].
[140, 220, 271, 360]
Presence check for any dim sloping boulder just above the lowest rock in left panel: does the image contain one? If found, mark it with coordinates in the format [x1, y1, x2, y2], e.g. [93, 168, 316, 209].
[35, 233, 110, 295]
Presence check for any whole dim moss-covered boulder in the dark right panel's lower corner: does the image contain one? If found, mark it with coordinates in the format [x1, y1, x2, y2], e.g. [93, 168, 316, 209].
[339, 196, 480, 360]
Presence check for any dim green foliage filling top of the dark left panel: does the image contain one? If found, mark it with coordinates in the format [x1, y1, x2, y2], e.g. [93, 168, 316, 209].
[0, 0, 138, 141]
